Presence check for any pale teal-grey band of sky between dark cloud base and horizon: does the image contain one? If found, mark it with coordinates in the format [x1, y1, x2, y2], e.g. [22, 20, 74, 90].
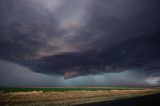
[0, 60, 153, 87]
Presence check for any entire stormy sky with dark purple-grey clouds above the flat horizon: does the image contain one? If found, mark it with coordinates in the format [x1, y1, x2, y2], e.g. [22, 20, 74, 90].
[0, 0, 160, 87]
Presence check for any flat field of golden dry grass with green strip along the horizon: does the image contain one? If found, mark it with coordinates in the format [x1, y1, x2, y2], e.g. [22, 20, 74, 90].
[0, 88, 160, 106]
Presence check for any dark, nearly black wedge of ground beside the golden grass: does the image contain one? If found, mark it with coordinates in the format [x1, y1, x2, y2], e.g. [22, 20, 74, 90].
[76, 93, 160, 106]
